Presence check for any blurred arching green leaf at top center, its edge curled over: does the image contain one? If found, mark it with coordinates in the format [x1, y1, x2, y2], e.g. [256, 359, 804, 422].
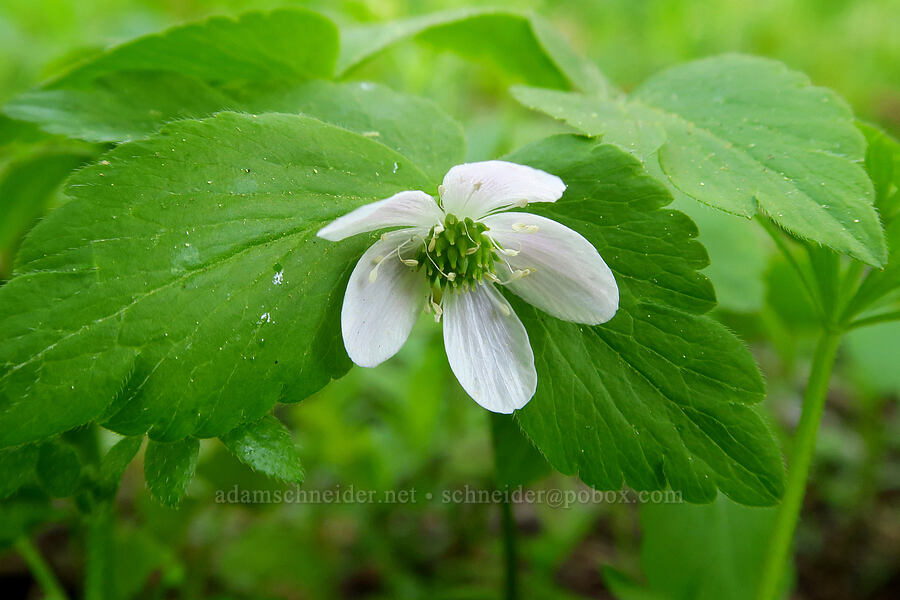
[337, 8, 608, 92]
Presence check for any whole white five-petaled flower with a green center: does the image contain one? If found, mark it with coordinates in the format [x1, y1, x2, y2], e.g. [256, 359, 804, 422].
[319, 160, 619, 413]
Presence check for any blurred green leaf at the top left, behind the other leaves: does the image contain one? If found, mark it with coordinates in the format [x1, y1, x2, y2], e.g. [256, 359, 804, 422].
[50, 9, 338, 86]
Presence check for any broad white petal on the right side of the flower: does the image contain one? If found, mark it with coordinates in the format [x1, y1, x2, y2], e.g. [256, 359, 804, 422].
[483, 212, 619, 325]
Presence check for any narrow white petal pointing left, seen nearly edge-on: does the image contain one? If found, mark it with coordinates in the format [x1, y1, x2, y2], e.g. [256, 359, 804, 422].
[318, 190, 443, 242]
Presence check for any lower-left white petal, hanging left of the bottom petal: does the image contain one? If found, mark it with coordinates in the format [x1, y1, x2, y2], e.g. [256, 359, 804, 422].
[341, 229, 427, 367]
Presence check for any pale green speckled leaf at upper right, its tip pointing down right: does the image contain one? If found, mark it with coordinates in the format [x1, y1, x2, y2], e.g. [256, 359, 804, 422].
[513, 55, 886, 266]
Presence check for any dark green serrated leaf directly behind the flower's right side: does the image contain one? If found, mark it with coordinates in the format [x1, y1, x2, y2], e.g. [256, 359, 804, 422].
[510, 136, 783, 504]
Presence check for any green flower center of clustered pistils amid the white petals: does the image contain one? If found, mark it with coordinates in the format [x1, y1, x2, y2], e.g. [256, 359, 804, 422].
[416, 214, 496, 298]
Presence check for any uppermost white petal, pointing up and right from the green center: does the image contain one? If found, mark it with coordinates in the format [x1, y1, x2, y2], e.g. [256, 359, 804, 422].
[441, 160, 566, 220]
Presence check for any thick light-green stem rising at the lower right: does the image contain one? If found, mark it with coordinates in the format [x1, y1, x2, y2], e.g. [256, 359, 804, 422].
[757, 330, 842, 600]
